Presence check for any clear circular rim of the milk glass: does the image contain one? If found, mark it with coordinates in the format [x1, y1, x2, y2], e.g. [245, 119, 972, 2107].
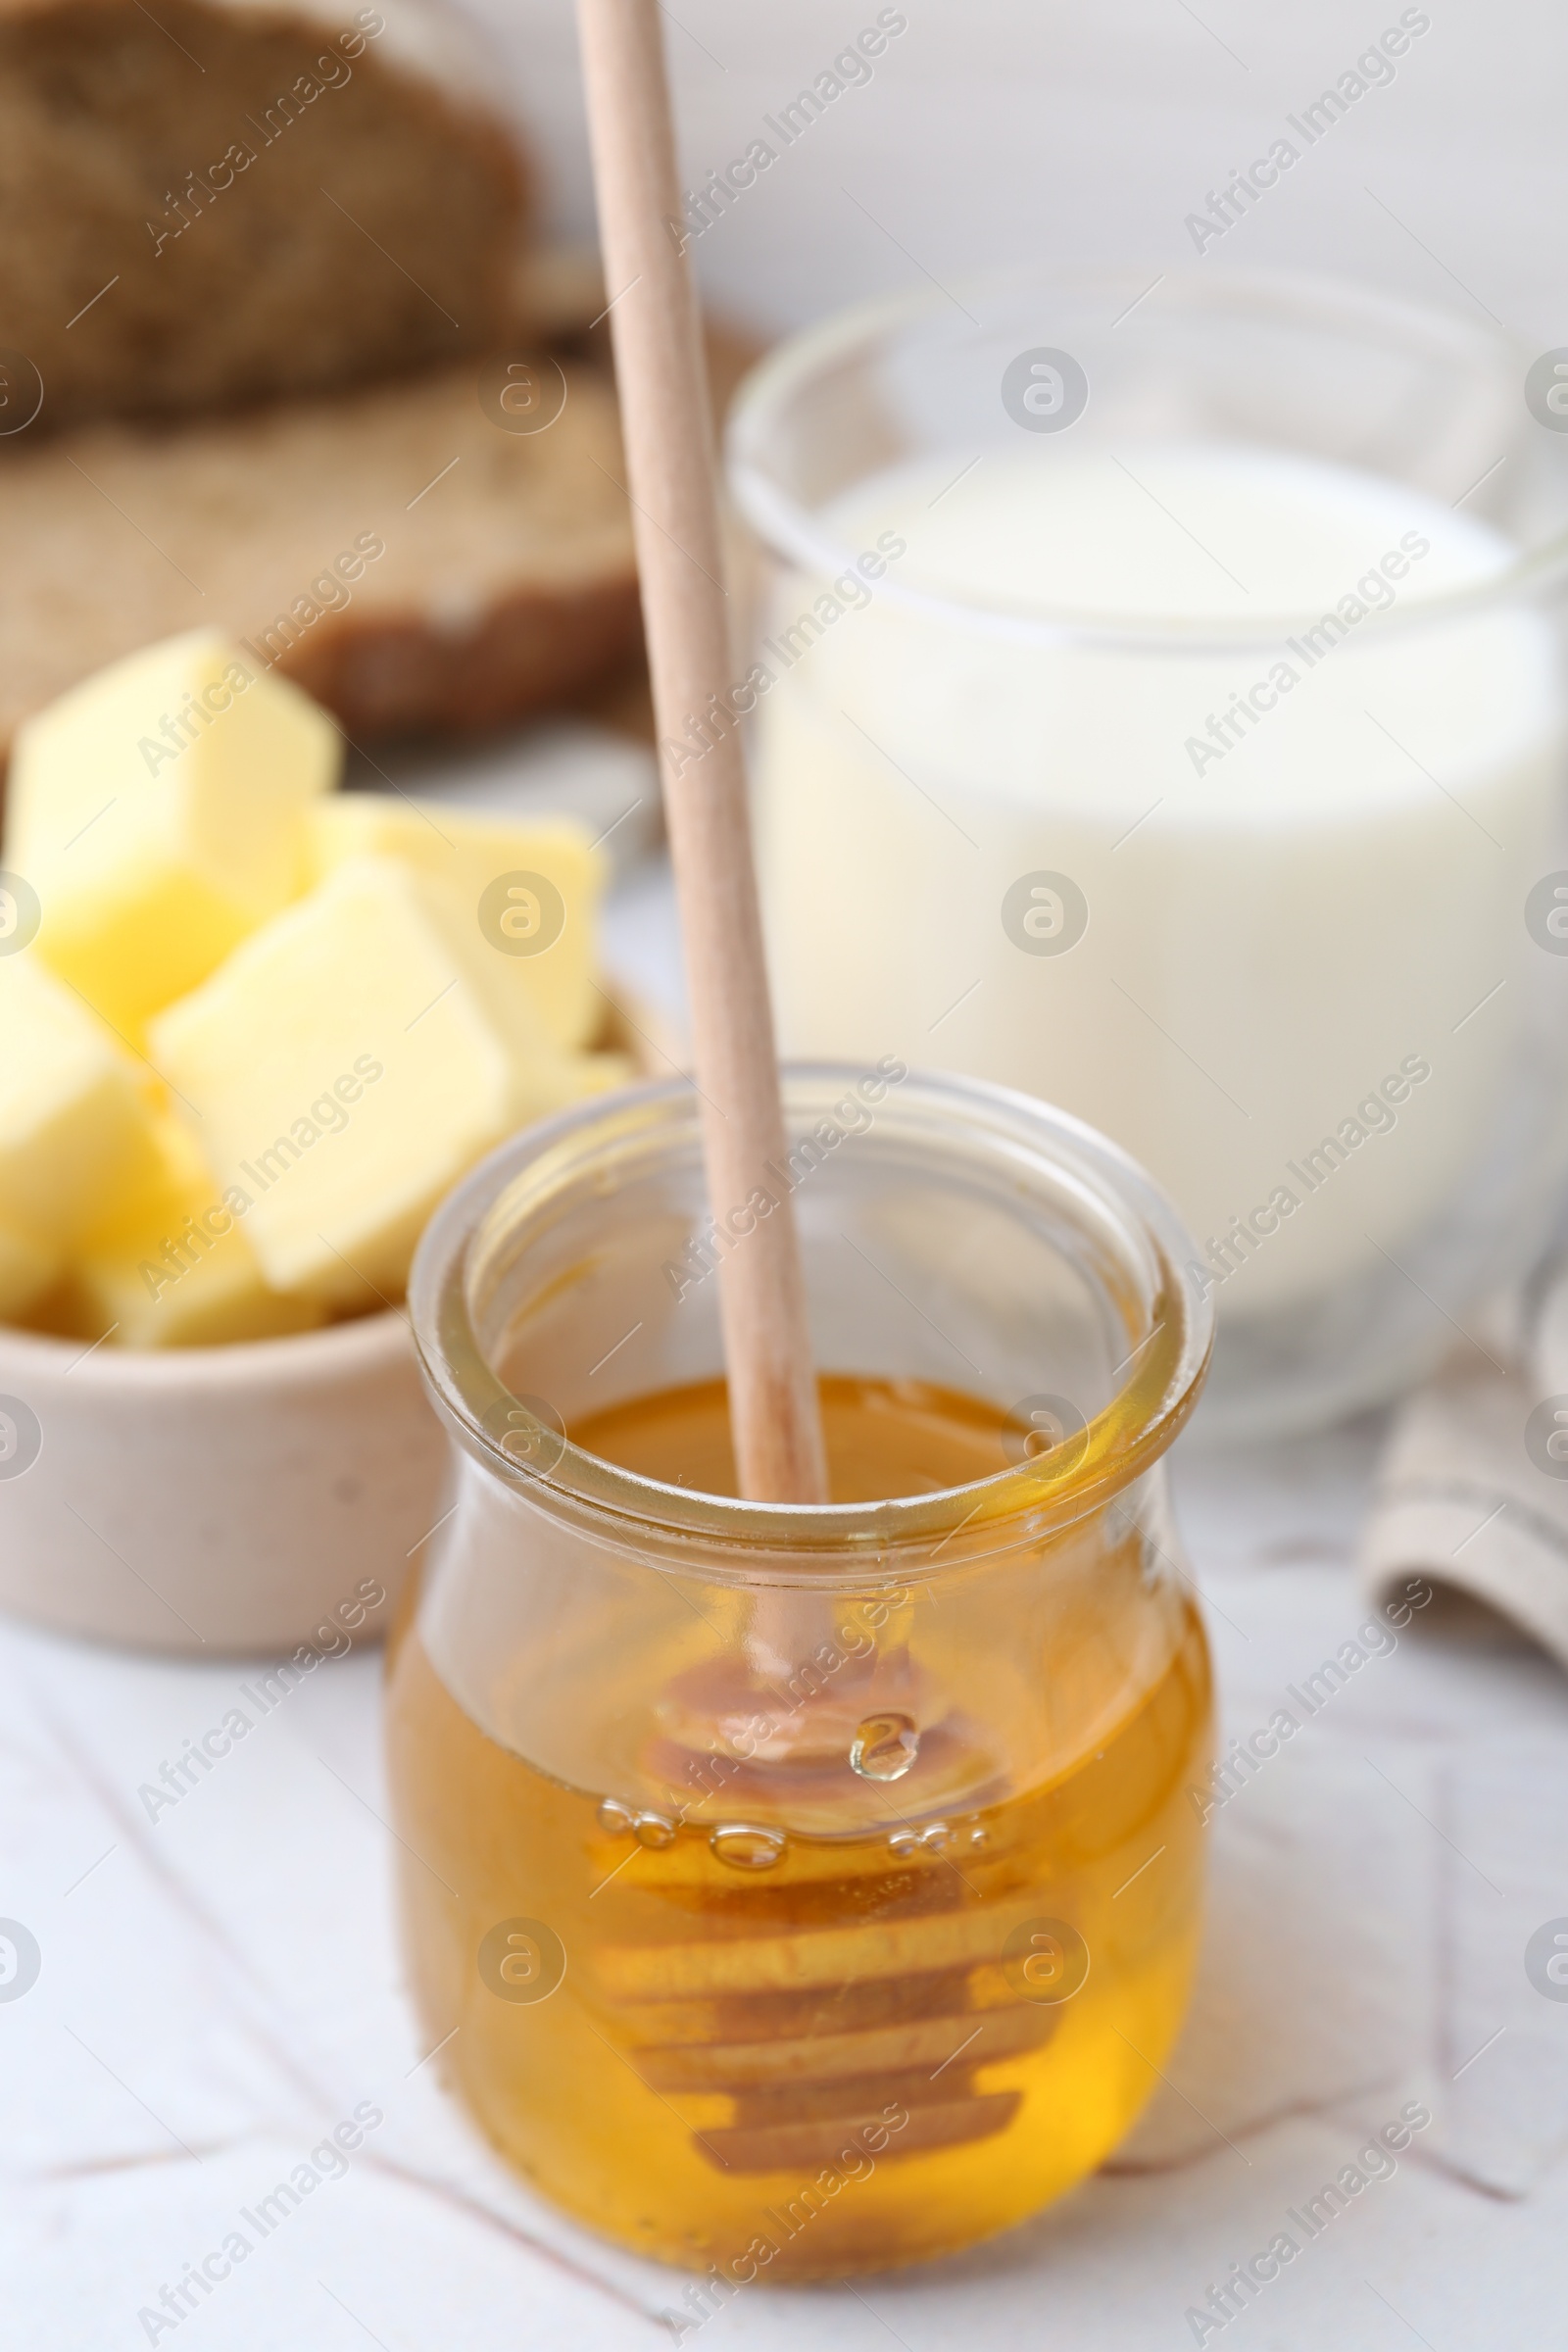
[724, 264, 1568, 657]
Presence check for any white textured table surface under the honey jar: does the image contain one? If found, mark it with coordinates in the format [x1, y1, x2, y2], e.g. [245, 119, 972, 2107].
[0, 868, 1568, 2352]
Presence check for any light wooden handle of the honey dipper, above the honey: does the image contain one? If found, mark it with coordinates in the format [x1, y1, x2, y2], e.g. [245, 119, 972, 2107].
[578, 0, 827, 1503]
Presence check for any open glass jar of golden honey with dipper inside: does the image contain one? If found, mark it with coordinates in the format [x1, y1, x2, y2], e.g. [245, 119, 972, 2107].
[388, 1058, 1210, 2286]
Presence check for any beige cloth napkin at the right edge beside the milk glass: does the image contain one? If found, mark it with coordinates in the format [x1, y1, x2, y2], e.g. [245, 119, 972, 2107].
[1361, 1256, 1568, 1668]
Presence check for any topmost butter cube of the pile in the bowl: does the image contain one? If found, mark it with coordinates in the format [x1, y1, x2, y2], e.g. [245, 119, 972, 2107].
[5, 630, 341, 1042]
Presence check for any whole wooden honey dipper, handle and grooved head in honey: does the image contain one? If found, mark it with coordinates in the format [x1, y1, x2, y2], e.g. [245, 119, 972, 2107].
[578, 0, 1054, 2174]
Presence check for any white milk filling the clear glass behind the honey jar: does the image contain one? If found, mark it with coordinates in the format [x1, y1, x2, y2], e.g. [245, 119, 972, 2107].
[755, 442, 1563, 1315]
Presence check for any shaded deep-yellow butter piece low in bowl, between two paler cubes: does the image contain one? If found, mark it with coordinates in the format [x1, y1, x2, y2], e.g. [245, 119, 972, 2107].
[52, 1112, 324, 1348]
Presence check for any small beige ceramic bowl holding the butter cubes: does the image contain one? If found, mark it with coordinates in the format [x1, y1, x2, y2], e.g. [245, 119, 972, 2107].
[0, 998, 679, 1658]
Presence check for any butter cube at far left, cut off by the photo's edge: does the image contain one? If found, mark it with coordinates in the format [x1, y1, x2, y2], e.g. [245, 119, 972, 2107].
[0, 951, 160, 1249]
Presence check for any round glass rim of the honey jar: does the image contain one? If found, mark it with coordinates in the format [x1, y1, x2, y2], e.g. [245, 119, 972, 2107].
[409, 1060, 1213, 1583]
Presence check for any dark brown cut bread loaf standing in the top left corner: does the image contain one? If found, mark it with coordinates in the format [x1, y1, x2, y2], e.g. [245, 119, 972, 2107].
[0, 0, 526, 432]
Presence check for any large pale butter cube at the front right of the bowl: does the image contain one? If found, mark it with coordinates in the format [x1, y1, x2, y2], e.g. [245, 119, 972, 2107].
[153, 858, 625, 1307]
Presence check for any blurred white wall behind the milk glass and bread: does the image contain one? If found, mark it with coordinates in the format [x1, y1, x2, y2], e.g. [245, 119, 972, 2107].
[477, 0, 1568, 346]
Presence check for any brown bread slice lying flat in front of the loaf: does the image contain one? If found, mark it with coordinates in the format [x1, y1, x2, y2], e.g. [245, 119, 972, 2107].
[0, 363, 639, 746]
